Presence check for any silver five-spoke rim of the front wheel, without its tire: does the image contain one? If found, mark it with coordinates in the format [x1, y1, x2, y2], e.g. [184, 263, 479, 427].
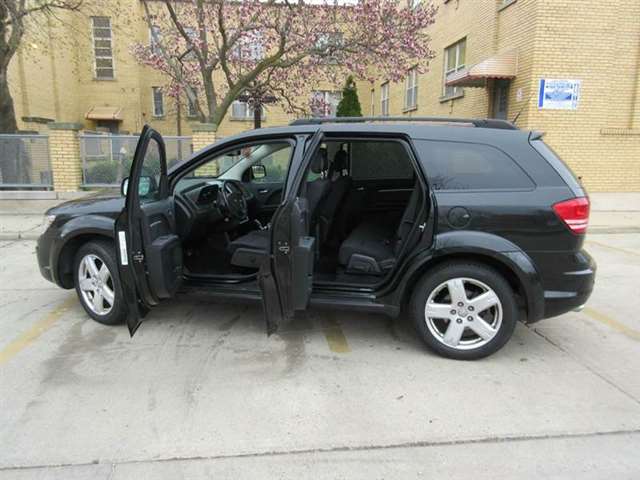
[78, 253, 115, 315]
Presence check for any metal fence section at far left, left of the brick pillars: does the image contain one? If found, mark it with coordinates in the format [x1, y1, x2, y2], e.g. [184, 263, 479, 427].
[0, 134, 53, 190]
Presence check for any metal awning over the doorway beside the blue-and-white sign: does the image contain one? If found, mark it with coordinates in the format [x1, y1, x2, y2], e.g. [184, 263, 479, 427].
[445, 49, 518, 87]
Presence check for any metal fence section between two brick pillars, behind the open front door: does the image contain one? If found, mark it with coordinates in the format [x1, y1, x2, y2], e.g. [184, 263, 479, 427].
[80, 133, 193, 187]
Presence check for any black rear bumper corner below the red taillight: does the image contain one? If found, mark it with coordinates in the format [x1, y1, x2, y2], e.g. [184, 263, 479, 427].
[543, 250, 596, 318]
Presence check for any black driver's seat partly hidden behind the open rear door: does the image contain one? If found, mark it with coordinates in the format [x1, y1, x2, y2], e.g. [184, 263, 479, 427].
[227, 149, 330, 268]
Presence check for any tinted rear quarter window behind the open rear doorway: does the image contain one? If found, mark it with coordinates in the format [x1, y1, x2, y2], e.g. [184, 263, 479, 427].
[416, 140, 535, 190]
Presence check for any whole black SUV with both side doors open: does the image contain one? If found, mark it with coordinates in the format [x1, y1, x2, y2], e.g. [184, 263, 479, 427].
[38, 118, 595, 359]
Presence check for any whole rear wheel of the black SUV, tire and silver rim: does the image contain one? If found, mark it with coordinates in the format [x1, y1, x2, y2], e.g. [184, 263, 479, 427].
[411, 262, 518, 360]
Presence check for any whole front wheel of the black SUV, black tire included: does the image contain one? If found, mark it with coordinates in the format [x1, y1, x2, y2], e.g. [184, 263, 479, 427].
[73, 240, 127, 325]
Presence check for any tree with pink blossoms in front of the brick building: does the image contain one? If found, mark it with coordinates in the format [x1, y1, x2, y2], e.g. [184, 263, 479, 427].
[132, 0, 436, 129]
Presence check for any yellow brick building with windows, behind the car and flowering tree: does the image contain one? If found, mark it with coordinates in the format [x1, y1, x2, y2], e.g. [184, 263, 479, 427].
[10, 0, 640, 191]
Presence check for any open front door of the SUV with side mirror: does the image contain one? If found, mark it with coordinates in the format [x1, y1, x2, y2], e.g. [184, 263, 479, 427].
[115, 125, 182, 336]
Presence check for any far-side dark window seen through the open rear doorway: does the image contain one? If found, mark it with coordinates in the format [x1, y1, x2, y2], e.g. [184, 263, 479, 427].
[351, 141, 414, 180]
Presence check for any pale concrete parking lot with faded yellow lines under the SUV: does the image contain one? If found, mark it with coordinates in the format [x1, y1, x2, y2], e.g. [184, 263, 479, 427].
[0, 233, 640, 479]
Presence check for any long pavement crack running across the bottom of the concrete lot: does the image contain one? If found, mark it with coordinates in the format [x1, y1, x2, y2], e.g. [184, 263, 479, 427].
[0, 428, 640, 472]
